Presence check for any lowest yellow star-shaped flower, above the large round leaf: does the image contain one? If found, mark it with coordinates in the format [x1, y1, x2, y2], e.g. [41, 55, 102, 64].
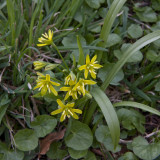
[51, 99, 82, 122]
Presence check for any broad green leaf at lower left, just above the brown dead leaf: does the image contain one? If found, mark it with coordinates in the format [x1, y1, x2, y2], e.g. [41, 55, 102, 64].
[31, 115, 57, 137]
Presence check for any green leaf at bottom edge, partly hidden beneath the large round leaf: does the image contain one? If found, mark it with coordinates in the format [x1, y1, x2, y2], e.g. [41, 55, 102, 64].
[68, 148, 88, 159]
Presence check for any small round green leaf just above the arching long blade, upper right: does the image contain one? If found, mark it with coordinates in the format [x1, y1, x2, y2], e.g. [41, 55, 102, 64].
[127, 24, 143, 38]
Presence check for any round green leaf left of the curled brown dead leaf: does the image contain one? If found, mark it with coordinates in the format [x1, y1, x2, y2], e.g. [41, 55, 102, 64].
[14, 129, 38, 151]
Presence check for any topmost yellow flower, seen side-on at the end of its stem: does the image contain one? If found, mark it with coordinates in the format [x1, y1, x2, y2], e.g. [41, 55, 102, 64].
[37, 29, 53, 47]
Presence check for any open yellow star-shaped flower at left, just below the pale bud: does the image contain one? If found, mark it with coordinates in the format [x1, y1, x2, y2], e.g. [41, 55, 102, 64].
[34, 72, 60, 96]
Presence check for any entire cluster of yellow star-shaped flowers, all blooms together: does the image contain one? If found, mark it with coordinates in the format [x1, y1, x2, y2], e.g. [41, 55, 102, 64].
[33, 30, 102, 122]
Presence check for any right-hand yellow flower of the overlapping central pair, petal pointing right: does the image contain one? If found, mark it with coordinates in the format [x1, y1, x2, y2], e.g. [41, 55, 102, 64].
[73, 79, 97, 96]
